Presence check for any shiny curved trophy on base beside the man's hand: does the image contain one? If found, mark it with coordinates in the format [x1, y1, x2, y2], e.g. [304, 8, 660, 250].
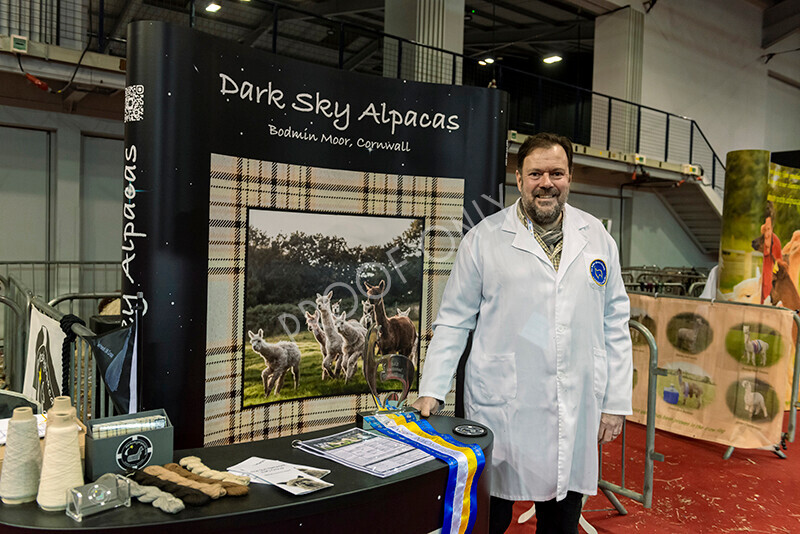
[356, 325, 419, 428]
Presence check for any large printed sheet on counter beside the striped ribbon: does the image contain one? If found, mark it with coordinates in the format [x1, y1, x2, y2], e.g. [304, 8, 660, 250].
[292, 428, 433, 477]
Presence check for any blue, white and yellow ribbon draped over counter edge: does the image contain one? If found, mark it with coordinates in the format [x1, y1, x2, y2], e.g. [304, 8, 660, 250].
[365, 414, 486, 534]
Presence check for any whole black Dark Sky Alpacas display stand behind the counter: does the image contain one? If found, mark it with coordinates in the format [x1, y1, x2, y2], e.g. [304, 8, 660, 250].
[122, 22, 507, 448]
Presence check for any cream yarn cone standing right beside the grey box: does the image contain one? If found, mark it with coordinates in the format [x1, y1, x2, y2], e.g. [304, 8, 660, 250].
[36, 406, 83, 511]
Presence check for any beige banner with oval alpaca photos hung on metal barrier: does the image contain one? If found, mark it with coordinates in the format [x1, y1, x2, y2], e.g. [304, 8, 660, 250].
[629, 294, 795, 448]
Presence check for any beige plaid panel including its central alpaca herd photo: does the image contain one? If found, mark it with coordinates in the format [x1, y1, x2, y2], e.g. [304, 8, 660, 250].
[206, 154, 464, 448]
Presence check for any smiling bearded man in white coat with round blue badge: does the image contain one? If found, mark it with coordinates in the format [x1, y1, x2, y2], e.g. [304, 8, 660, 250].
[414, 133, 633, 534]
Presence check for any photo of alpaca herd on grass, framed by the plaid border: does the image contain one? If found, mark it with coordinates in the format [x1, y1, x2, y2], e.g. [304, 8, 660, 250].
[242, 208, 424, 408]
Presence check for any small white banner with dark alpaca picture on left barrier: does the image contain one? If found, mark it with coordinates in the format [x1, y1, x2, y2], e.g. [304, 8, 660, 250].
[22, 306, 66, 411]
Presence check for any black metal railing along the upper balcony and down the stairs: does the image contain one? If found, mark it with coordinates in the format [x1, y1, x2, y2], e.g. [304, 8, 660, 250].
[0, 0, 725, 191]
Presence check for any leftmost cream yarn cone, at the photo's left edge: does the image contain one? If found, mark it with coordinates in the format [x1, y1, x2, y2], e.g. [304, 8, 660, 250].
[0, 407, 42, 504]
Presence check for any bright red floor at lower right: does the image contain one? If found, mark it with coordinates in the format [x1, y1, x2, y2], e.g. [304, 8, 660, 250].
[507, 416, 800, 534]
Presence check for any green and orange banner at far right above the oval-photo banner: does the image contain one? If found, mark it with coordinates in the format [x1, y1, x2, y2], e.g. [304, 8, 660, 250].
[717, 150, 800, 310]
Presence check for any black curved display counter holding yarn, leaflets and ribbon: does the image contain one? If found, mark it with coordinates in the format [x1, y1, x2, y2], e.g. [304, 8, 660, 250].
[0, 416, 493, 534]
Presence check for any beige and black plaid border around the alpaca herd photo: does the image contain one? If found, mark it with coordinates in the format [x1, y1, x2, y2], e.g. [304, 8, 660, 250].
[204, 154, 464, 446]
